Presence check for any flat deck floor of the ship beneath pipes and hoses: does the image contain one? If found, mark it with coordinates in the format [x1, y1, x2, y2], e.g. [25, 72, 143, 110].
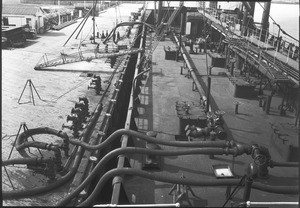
[124, 35, 298, 207]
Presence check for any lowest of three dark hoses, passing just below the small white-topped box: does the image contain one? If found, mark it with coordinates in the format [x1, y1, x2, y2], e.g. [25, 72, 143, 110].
[78, 168, 299, 207]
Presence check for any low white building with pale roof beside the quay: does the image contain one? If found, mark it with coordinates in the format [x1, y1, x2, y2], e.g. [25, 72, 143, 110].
[2, 4, 45, 33]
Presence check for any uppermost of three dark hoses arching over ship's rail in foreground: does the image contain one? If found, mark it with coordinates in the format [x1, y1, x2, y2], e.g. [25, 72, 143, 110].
[69, 129, 231, 150]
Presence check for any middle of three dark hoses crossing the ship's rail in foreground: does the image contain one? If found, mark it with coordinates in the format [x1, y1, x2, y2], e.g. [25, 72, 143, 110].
[56, 147, 235, 206]
